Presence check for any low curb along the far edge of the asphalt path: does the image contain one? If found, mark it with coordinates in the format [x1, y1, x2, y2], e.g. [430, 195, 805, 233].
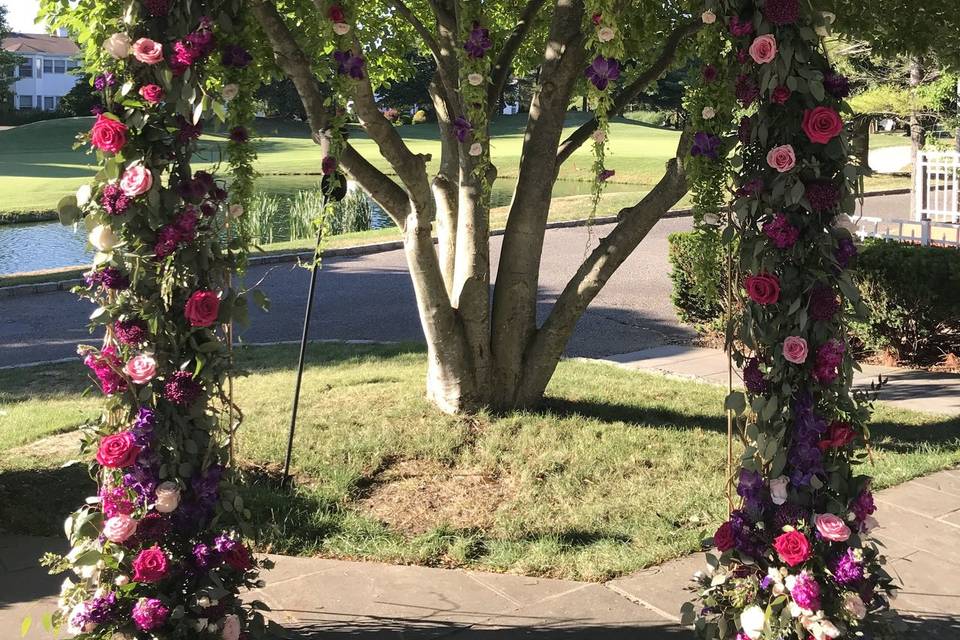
[0, 189, 911, 298]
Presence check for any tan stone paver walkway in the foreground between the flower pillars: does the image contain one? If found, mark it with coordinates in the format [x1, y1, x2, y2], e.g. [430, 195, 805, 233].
[0, 470, 960, 640]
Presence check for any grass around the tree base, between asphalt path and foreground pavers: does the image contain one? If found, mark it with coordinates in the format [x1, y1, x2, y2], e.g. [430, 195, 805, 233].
[0, 344, 960, 580]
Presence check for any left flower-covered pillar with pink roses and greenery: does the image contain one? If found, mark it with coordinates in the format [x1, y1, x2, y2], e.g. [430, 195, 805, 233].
[38, 0, 264, 640]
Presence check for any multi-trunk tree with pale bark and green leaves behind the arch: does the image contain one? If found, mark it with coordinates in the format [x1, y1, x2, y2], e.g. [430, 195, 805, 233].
[250, 0, 702, 411]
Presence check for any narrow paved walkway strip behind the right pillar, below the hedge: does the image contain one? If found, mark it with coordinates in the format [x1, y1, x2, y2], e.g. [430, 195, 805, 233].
[601, 345, 960, 415]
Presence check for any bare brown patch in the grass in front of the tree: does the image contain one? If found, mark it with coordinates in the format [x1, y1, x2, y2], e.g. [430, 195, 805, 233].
[356, 460, 515, 535]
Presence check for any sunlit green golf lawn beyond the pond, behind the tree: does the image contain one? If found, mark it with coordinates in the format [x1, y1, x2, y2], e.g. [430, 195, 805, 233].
[0, 113, 908, 220]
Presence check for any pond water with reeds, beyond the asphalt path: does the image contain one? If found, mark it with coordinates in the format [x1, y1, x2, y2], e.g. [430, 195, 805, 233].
[0, 179, 638, 275]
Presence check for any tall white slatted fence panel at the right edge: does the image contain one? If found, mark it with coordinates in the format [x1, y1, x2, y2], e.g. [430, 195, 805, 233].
[913, 151, 960, 223]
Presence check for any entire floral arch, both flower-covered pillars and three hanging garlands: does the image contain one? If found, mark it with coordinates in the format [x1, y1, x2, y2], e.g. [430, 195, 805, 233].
[37, 0, 891, 640]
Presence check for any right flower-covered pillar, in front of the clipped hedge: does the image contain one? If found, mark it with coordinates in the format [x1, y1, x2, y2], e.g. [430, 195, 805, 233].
[684, 0, 893, 640]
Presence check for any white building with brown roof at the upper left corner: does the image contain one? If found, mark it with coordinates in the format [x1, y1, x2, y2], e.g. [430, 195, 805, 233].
[3, 31, 80, 111]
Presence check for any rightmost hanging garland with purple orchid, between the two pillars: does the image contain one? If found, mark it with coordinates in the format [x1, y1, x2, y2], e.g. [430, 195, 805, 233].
[584, 0, 625, 220]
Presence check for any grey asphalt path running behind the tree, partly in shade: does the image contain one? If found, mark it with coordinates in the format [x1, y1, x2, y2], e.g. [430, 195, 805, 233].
[0, 196, 909, 366]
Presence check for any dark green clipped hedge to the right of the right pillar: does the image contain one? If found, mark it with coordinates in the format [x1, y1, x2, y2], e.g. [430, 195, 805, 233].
[853, 240, 960, 365]
